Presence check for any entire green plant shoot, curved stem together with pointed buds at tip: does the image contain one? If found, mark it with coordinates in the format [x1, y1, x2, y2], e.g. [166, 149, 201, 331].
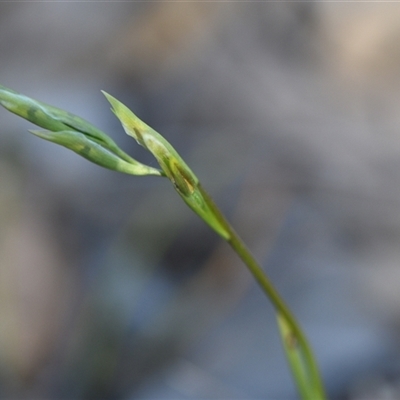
[0, 85, 325, 400]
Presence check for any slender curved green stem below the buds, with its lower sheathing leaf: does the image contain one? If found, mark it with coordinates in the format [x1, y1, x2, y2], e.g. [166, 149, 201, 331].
[198, 185, 326, 400]
